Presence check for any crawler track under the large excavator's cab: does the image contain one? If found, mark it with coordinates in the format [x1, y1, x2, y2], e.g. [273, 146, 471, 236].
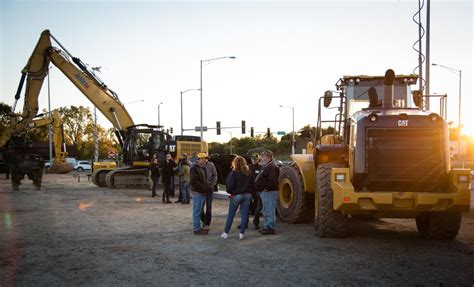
[105, 167, 150, 189]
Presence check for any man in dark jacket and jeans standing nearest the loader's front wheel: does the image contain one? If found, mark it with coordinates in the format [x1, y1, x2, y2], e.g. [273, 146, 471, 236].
[255, 150, 280, 235]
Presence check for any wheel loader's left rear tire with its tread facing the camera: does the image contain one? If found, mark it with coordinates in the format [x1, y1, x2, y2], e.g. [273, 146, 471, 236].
[314, 163, 347, 238]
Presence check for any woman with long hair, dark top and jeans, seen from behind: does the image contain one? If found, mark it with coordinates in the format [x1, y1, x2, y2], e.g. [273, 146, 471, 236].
[221, 156, 253, 239]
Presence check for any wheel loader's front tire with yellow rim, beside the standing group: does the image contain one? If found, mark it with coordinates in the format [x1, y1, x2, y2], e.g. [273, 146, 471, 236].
[277, 163, 314, 223]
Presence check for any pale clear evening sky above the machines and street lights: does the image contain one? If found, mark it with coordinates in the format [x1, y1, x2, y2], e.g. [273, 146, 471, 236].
[0, 0, 474, 142]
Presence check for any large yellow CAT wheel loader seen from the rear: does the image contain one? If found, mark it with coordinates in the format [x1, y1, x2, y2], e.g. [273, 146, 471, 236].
[277, 69, 471, 239]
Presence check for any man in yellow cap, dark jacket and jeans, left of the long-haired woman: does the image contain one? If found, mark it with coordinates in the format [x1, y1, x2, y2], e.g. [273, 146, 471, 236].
[189, 153, 212, 235]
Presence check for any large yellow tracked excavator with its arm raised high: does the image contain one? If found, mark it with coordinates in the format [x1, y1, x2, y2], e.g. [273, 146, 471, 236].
[0, 30, 207, 191]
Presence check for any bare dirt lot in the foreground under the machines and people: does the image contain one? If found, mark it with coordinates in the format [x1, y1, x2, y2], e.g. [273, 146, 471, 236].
[0, 174, 474, 287]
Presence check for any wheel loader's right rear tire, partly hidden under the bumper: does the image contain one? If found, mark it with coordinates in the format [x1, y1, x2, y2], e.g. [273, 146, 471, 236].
[416, 212, 462, 240]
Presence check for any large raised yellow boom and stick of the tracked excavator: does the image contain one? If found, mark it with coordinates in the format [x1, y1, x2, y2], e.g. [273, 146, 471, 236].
[0, 30, 134, 151]
